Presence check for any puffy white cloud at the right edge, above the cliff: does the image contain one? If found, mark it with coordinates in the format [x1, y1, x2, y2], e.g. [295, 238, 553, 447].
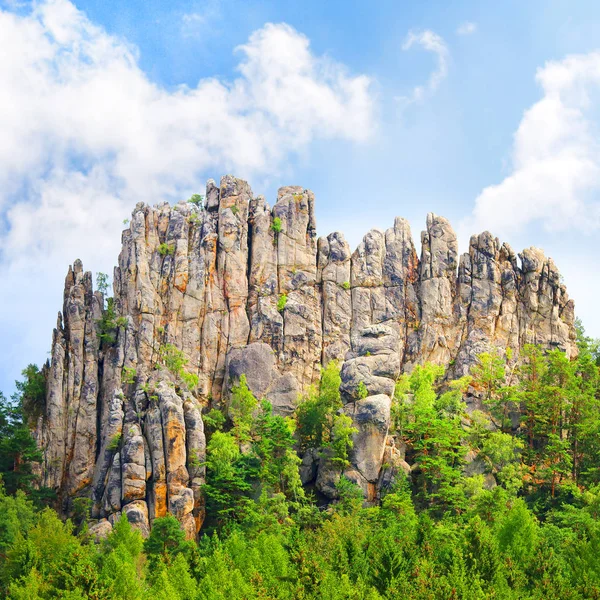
[469, 52, 600, 235]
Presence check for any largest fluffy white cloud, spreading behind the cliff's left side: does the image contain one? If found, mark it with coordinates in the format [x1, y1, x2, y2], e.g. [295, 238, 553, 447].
[0, 0, 374, 392]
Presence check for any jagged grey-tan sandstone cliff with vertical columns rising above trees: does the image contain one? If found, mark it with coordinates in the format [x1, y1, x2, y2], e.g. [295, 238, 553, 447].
[36, 176, 576, 537]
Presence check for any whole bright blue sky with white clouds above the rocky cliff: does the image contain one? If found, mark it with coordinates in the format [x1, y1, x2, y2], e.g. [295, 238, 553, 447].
[0, 0, 600, 393]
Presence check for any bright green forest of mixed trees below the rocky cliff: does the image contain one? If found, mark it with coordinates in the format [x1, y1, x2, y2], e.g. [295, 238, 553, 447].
[0, 326, 600, 600]
